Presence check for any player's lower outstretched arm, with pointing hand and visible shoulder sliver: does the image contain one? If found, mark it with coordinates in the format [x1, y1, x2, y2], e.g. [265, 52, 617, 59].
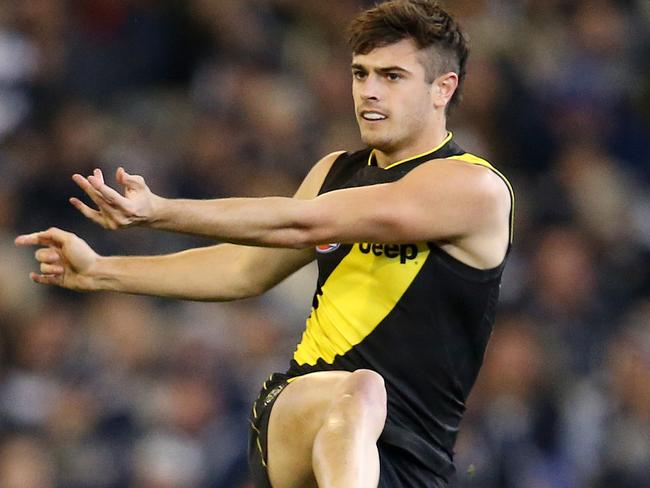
[16, 153, 340, 301]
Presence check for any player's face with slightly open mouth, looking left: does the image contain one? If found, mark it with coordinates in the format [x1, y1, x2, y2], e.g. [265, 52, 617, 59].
[352, 39, 434, 153]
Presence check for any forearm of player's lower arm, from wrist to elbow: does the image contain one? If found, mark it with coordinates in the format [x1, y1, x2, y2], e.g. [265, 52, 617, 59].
[86, 245, 253, 301]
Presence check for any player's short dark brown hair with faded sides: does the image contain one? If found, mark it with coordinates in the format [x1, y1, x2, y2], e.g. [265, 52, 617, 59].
[348, 0, 469, 105]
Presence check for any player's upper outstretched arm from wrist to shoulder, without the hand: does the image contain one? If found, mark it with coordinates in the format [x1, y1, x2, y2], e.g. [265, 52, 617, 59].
[82, 160, 510, 252]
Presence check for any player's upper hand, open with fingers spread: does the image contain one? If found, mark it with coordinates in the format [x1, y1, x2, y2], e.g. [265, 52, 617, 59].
[70, 168, 159, 230]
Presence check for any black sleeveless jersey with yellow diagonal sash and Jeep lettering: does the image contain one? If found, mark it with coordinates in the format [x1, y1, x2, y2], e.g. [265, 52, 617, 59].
[288, 134, 514, 478]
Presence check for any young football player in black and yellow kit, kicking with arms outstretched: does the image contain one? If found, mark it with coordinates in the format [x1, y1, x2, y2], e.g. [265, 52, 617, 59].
[16, 0, 513, 488]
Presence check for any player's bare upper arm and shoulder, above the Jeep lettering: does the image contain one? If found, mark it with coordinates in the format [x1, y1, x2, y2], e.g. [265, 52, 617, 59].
[310, 161, 509, 243]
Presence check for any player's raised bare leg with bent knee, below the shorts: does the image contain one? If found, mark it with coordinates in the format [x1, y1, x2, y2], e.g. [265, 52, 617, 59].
[268, 370, 386, 488]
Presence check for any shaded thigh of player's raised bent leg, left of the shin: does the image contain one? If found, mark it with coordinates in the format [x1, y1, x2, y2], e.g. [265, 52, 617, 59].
[267, 371, 352, 488]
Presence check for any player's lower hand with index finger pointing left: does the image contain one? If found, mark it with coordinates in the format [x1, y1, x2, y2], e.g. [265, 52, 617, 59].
[15, 227, 99, 291]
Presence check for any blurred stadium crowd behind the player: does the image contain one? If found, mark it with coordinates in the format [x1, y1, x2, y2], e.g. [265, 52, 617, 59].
[0, 0, 650, 488]
